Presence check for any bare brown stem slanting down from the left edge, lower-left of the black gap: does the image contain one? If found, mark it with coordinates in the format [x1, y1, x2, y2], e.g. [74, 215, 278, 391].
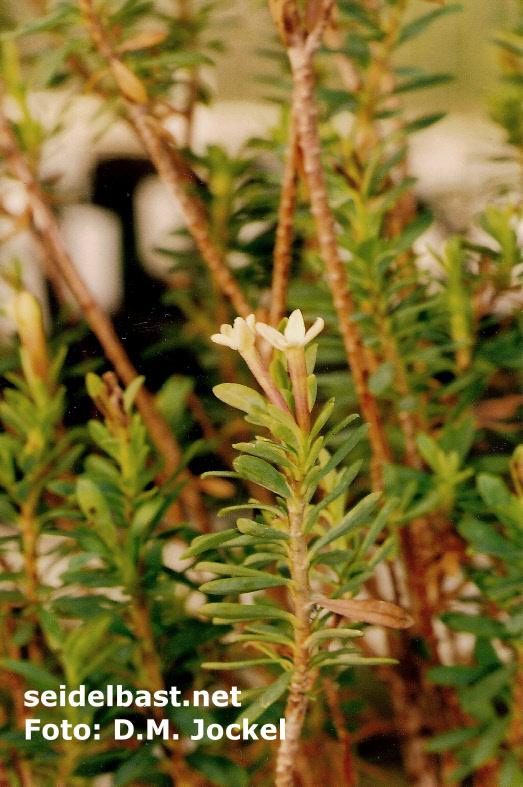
[0, 104, 206, 524]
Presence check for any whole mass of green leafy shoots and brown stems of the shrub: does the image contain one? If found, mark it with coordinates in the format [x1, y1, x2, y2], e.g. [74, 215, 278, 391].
[0, 0, 523, 787]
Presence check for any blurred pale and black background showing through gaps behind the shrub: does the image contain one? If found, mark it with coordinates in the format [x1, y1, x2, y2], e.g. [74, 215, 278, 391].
[0, 0, 518, 376]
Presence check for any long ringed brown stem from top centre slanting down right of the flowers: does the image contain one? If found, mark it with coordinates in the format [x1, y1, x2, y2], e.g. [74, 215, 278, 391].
[288, 37, 391, 488]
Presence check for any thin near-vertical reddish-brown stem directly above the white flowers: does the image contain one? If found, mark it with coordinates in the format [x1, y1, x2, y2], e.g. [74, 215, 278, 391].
[268, 116, 300, 328]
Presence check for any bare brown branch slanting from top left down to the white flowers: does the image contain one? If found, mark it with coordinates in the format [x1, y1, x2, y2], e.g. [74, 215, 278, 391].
[78, 0, 252, 324]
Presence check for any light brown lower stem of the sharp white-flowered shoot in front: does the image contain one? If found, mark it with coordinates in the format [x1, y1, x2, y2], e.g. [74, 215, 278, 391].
[275, 495, 316, 787]
